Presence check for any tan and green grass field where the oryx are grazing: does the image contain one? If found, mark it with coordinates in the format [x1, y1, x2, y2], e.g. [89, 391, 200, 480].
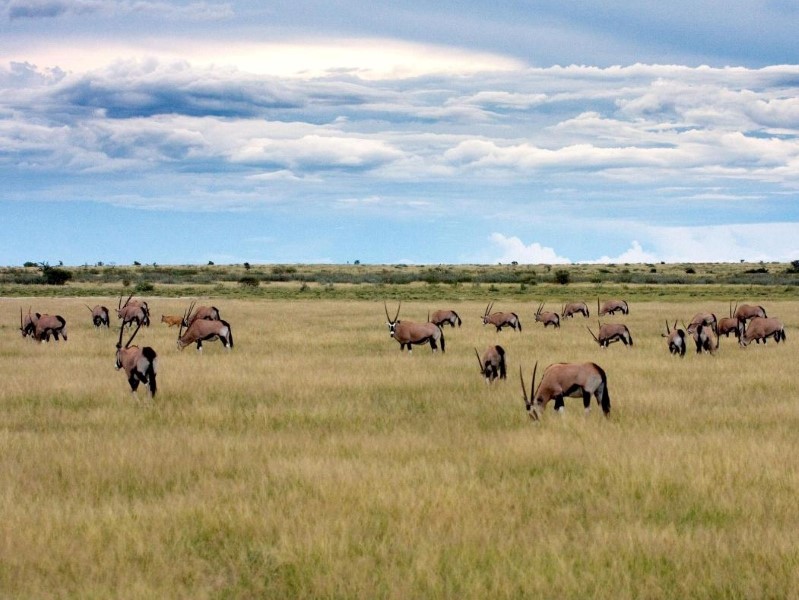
[0, 298, 799, 599]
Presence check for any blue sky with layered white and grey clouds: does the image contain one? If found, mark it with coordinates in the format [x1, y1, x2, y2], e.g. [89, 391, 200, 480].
[0, 0, 799, 265]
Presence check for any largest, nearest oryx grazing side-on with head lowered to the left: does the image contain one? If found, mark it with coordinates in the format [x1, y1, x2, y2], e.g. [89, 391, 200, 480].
[519, 362, 610, 421]
